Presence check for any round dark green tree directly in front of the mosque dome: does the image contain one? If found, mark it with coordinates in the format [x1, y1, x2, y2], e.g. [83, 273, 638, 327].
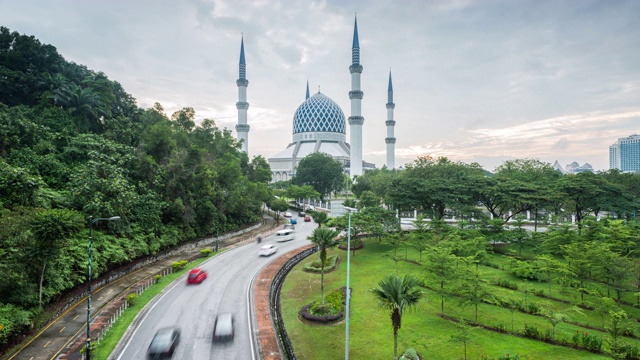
[291, 152, 343, 200]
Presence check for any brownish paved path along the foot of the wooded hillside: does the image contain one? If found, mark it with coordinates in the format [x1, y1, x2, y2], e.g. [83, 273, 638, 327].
[6, 217, 276, 360]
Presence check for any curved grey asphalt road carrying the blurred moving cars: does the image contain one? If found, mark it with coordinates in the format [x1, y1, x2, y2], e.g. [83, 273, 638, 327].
[112, 218, 316, 360]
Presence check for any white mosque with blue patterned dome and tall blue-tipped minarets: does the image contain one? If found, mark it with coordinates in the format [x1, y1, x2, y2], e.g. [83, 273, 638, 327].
[236, 18, 396, 182]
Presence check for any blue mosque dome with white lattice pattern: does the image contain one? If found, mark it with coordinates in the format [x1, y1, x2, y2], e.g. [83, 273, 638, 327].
[293, 92, 346, 134]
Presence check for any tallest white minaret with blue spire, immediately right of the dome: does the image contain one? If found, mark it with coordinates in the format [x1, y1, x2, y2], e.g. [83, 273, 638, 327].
[349, 18, 364, 178]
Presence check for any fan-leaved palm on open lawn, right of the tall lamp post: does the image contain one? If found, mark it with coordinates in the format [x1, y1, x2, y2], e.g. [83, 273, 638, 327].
[370, 274, 423, 360]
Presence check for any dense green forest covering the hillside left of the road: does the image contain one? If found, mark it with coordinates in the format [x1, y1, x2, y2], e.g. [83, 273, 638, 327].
[0, 27, 272, 348]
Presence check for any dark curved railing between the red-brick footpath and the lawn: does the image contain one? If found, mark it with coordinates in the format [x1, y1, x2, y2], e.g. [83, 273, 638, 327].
[269, 246, 318, 360]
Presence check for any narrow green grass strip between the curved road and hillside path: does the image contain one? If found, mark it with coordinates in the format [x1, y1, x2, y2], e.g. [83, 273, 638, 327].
[93, 257, 210, 360]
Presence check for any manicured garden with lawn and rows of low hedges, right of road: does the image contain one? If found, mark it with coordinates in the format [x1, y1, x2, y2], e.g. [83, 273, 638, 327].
[282, 222, 640, 359]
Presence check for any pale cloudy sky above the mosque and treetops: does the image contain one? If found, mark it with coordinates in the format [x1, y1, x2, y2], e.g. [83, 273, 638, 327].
[0, 0, 640, 171]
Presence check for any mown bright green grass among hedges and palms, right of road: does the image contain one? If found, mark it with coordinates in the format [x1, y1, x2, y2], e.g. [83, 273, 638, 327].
[281, 239, 620, 360]
